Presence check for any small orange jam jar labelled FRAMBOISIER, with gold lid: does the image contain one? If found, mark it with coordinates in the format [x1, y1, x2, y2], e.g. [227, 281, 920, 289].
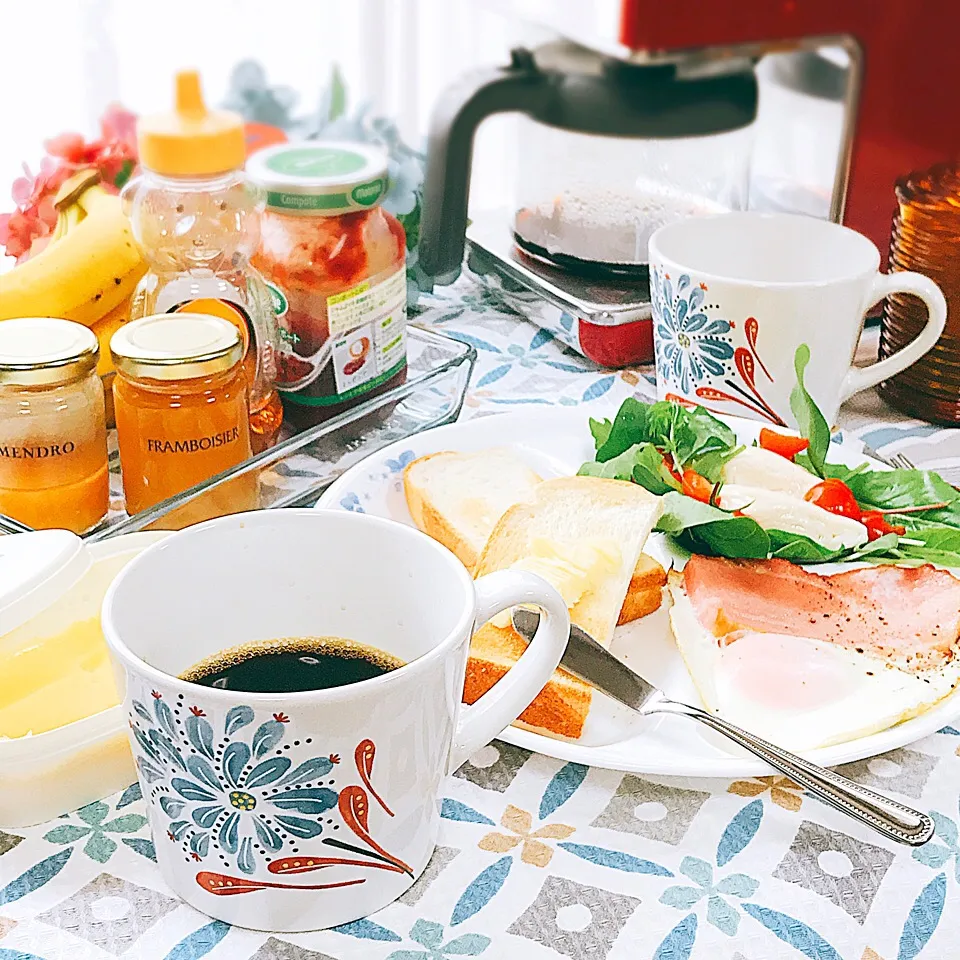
[110, 313, 257, 527]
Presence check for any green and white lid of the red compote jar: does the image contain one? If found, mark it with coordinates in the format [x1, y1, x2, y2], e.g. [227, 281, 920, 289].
[247, 140, 389, 216]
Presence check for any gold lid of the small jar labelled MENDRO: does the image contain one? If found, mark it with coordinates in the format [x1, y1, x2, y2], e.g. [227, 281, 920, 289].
[0, 317, 100, 387]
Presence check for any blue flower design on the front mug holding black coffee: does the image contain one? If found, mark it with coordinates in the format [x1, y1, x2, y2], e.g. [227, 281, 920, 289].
[130, 691, 340, 874]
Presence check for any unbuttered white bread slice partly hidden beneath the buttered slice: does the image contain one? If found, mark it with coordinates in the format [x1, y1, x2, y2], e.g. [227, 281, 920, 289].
[403, 447, 667, 624]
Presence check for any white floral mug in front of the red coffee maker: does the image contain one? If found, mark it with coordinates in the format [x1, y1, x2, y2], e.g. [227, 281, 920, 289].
[650, 213, 947, 426]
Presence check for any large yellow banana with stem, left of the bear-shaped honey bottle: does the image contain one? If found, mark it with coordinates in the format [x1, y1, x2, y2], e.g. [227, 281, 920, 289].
[0, 171, 147, 327]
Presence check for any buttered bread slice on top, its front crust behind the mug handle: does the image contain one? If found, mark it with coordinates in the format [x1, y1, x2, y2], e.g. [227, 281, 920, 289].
[464, 477, 660, 739]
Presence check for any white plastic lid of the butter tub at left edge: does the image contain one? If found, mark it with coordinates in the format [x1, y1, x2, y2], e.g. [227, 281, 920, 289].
[0, 530, 92, 638]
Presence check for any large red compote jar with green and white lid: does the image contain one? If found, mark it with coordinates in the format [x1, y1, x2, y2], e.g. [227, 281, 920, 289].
[247, 142, 407, 427]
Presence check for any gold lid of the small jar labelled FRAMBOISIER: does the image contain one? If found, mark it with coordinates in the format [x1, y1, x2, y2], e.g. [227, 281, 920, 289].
[110, 313, 243, 380]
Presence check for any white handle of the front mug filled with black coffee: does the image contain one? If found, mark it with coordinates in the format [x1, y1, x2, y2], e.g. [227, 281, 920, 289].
[448, 570, 570, 773]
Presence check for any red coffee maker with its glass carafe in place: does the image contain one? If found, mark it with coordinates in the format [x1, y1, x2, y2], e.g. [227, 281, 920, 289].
[418, 0, 960, 366]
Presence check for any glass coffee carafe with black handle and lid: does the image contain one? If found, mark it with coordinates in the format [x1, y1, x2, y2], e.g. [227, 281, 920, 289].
[419, 42, 757, 282]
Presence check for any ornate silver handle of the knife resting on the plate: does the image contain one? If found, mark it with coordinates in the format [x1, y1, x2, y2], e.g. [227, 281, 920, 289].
[645, 699, 934, 847]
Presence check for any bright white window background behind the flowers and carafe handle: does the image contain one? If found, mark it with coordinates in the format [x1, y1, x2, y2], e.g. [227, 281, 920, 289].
[0, 0, 542, 223]
